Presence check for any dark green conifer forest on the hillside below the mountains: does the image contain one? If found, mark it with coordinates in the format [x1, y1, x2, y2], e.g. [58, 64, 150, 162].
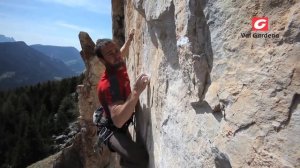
[0, 75, 83, 168]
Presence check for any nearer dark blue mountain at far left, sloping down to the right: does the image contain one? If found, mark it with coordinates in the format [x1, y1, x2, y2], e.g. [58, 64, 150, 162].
[0, 41, 76, 90]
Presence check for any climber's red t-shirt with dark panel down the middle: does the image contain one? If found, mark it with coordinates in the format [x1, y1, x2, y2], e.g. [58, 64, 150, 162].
[97, 64, 131, 115]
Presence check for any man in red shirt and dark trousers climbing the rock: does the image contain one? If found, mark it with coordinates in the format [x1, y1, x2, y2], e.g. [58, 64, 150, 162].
[95, 31, 149, 167]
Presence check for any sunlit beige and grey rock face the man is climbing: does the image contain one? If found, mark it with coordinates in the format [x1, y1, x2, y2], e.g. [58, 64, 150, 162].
[124, 0, 300, 168]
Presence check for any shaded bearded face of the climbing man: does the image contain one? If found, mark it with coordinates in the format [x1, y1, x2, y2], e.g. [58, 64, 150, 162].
[101, 43, 123, 66]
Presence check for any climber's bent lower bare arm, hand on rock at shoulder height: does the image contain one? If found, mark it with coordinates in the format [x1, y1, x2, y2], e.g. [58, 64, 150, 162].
[109, 74, 149, 128]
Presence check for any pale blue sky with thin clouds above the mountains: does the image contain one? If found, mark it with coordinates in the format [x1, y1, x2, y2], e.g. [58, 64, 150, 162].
[0, 0, 112, 50]
